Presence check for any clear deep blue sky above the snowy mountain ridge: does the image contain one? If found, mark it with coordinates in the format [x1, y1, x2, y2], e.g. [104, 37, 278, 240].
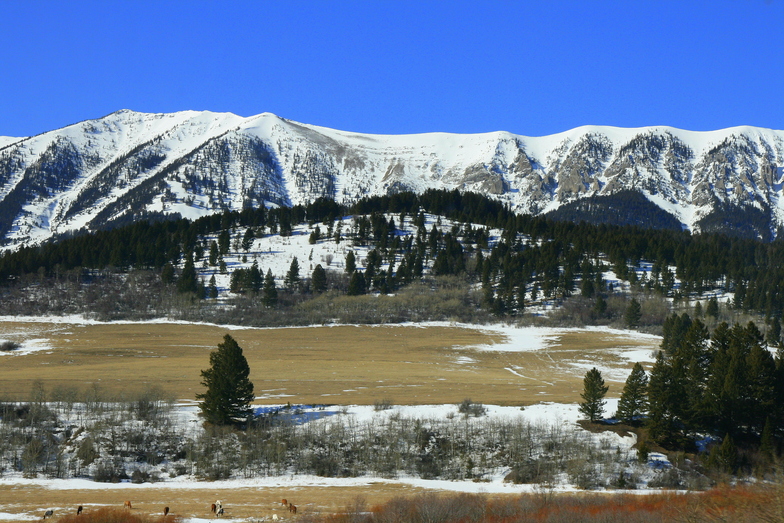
[0, 0, 784, 136]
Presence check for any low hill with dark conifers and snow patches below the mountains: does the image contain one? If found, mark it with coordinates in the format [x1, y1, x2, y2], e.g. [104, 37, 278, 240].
[0, 190, 784, 332]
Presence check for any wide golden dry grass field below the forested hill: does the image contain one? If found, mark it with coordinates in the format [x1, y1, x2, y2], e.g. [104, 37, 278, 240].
[0, 322, 658, 405]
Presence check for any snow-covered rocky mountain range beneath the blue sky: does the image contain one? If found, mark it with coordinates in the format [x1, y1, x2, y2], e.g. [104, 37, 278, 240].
[0, 110, 784, 247]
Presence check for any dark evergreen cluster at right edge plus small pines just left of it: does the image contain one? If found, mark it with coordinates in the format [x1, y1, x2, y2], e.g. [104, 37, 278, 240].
[580, 313, 784, 477]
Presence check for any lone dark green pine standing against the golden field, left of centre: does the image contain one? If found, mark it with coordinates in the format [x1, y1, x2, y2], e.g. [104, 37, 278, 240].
[196, 334, 254, 425]
